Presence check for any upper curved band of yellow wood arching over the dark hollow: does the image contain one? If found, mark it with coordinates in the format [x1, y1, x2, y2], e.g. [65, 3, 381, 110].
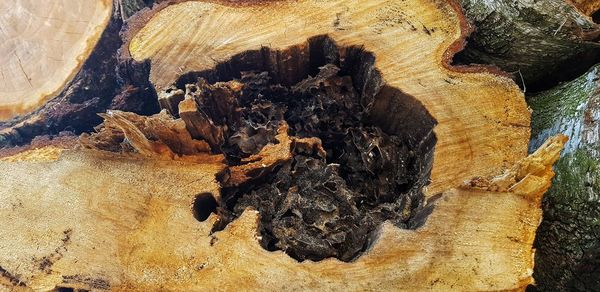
[128, 0, 529, 194]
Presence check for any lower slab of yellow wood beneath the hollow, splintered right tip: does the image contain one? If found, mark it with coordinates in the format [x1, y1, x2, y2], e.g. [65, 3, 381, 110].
[0, 137, 565, 291]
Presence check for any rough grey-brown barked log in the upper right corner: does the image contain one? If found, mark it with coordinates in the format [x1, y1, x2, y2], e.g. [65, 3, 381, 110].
[455, 0, 600, 90]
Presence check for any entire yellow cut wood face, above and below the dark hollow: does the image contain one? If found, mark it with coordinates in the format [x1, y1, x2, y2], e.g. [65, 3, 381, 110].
[0, 0, 565, 291]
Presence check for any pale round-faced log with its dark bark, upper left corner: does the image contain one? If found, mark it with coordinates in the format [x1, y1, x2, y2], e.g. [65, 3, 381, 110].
[0, 0, 158, 147]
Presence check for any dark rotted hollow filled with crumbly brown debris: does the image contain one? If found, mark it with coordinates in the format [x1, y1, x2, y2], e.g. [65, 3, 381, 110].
[166, 36, 436, 261]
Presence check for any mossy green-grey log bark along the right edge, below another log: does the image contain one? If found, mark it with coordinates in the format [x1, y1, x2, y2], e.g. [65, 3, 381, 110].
[529, 66, 600, 291]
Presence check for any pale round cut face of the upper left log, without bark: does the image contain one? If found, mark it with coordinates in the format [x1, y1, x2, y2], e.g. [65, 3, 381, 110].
[0, 0, 112, 120]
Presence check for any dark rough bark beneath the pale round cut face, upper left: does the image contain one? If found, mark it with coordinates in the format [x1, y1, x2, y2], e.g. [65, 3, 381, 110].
[0, 0, 158, 147]
